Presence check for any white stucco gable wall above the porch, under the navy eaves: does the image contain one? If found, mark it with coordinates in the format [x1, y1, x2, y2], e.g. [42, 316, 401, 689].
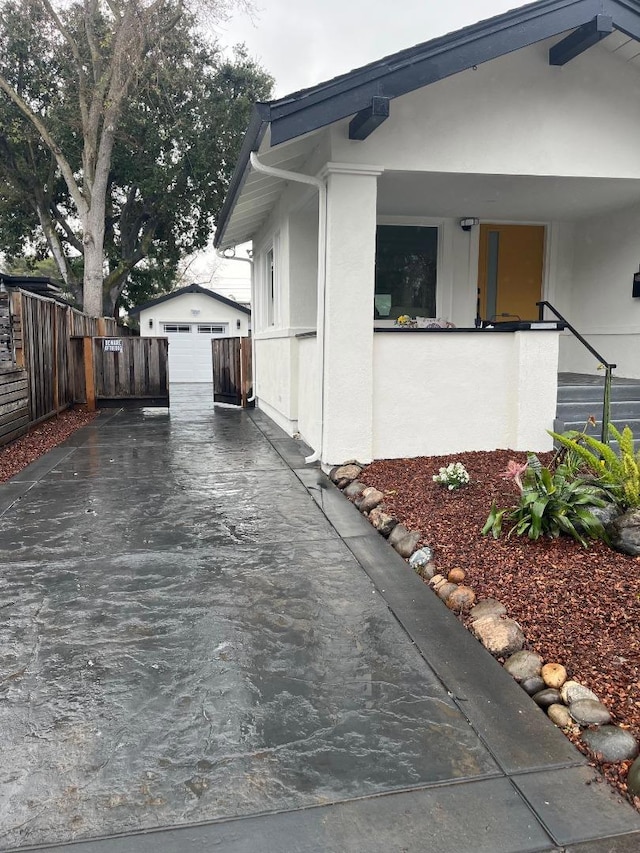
[331, 38, 640, 178]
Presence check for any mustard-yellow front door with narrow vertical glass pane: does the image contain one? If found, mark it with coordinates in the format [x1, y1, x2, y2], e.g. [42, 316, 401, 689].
[478, 225, 544, 321]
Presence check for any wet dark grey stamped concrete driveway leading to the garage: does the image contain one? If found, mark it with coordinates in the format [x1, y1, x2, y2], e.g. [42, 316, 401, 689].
[0, 386, 640, 853]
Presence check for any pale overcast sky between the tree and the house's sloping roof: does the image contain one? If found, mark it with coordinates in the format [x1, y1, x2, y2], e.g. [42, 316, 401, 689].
[218, 0, 526, 97]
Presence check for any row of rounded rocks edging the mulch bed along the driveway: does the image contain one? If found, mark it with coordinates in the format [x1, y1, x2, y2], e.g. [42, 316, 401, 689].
[329, 461, 640, 797]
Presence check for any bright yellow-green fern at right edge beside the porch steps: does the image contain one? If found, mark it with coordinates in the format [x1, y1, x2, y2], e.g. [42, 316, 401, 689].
[549, 424, 640, 508]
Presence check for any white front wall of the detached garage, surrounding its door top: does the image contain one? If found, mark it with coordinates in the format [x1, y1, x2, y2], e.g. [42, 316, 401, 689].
[140, 293, 249, 337]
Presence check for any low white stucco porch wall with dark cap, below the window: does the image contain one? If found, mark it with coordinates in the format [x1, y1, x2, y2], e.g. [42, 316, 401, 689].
[372, 331, 558, 461]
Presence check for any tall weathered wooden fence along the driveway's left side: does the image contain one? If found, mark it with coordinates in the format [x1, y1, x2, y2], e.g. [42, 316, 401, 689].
[0, 290, 121, 445]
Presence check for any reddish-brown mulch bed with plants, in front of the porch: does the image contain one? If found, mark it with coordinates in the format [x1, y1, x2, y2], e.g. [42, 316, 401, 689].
[359, 450, 640, 809]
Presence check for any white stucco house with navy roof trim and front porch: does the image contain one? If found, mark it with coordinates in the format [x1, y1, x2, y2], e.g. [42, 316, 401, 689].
[216, 0, 640, 464]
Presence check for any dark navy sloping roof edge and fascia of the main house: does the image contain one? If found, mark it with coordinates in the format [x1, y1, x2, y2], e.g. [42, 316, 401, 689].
[214, 0, 640, 246]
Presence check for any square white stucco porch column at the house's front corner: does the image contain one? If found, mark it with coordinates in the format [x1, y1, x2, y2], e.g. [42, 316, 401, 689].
[322, 163, 382, 465]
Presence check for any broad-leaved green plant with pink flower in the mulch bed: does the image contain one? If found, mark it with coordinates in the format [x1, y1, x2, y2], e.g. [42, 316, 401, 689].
[482, 453, 606, 548]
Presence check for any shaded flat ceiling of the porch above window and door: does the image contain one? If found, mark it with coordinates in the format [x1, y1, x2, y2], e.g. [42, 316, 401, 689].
[378, 171, 640, 222]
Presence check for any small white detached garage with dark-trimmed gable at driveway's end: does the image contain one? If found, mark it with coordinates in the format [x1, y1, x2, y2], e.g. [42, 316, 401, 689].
[129, 284, 251, 382]
